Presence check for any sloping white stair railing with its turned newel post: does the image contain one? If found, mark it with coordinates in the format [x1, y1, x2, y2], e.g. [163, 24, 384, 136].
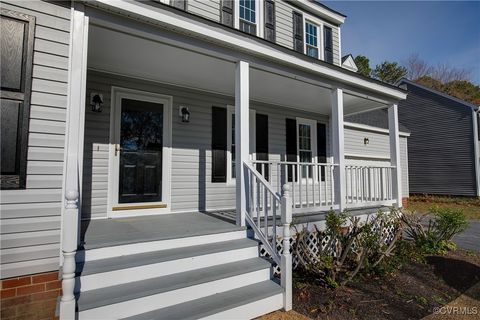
[244, 163, 292, 311]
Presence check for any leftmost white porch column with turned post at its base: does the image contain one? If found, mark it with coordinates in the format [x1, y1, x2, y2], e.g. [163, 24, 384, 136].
[60, 4, 88, 320]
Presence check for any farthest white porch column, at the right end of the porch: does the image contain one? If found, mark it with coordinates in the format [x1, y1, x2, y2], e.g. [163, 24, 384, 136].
[388, 104, 402, 208]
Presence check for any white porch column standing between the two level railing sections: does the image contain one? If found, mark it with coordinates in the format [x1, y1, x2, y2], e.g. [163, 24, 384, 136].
[331, 88, 346, 211]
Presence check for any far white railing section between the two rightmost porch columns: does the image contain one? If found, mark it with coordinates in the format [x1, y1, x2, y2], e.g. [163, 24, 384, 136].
[345, 165, 396, 207]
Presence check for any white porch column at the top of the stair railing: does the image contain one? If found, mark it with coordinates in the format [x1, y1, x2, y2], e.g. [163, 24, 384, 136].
[235, 61, 250, 226]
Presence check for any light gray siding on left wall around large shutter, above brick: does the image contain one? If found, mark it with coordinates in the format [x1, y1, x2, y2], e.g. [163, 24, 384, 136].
[0, 1, 70, 278]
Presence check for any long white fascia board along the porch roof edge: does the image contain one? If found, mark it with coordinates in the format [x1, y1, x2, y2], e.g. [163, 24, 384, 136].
[86, 0, 407, 101]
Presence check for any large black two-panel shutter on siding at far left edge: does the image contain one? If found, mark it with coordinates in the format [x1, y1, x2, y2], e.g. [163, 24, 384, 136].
[0, 8, 35, 189]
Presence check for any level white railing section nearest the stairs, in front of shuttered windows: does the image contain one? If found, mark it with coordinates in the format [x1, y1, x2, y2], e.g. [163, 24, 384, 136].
[252, 160, 338, 213]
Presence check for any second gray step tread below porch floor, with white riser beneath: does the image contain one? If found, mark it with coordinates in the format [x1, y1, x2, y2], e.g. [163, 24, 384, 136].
[77, 257, 279, 319]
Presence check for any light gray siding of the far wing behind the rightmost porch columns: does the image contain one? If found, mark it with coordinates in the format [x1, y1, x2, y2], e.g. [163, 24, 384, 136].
[345, 128, 409, 197]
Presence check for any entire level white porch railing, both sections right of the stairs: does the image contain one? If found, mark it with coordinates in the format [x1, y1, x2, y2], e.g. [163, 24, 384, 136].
[252, 160, 396, 213]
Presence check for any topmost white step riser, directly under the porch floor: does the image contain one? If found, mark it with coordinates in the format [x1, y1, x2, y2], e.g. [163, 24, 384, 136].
[80, 230, 247, 262]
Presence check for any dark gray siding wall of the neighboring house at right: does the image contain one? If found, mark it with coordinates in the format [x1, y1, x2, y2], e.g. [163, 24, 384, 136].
[398, 84, 476, 196]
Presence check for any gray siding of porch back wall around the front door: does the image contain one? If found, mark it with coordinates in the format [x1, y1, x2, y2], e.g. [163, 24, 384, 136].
[82, 72, 330, 219]
